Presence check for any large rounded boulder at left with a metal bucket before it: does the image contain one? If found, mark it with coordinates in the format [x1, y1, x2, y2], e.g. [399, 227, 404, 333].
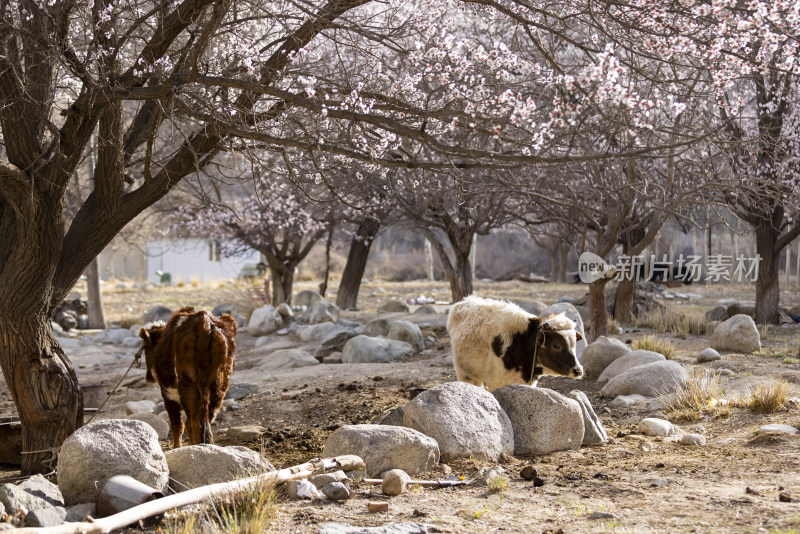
[57, 419, 169, 505]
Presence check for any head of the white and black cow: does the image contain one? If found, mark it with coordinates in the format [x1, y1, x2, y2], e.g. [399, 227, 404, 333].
[536, 313, 583, 378]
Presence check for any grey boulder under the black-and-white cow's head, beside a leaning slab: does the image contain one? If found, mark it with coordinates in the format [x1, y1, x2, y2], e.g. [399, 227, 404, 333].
[494, 384, 584, 456]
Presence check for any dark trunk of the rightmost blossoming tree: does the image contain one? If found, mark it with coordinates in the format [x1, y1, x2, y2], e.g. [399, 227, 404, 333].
[756, 221, 780, 324]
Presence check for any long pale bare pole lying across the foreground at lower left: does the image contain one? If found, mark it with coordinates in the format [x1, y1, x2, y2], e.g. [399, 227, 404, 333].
[14, 455, 364, 534]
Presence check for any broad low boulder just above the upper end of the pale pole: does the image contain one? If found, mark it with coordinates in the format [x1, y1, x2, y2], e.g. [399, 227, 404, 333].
[322, 425, 439, 476]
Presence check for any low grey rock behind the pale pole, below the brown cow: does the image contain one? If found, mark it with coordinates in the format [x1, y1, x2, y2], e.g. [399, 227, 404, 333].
[166, 444, 275, 491]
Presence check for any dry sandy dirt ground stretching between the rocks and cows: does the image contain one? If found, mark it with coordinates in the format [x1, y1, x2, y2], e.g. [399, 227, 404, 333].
[0, 281, 800, 533]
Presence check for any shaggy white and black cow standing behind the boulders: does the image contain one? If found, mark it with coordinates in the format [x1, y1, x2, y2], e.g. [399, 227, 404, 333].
[447, 296, 583, 391]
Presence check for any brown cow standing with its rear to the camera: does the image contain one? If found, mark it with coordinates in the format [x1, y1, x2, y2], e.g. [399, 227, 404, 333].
[139, 307, 236, 448]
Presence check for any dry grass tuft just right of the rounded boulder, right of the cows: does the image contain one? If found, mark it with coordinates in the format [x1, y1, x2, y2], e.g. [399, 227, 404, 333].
[664, 373, 730, 421]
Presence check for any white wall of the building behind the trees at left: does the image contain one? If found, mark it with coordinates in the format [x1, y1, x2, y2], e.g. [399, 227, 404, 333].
[147, 239, 260, 285]
